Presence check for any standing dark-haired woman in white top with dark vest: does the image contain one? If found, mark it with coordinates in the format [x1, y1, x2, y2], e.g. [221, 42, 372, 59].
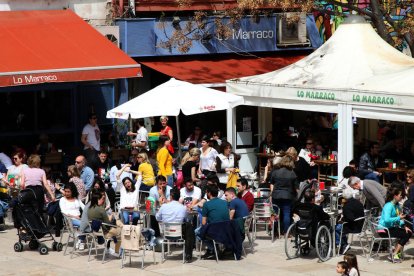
[216, 142, 239, 190]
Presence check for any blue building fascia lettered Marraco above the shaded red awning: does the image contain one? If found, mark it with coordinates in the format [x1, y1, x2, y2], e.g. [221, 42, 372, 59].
[117, 14, 322, 57]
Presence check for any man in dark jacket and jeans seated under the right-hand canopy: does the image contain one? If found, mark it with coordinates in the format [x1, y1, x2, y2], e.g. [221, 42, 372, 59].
[358, 142, 383, 182]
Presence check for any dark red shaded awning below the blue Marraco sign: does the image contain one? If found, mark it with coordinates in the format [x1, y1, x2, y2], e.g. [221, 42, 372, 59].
[139, 53, 305, 86]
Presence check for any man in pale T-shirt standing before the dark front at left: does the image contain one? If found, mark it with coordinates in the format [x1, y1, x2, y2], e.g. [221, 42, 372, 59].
[81, 113, 101, 164]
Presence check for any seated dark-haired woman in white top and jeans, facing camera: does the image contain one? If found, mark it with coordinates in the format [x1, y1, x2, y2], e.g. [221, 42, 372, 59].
[119, 177, 139, 225]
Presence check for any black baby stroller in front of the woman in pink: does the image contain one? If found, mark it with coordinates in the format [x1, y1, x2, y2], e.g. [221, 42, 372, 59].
[12, 189, 63, 255]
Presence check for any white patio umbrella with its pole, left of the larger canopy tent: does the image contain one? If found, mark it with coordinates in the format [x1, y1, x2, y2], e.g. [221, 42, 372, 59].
[106, 78, 244, 156]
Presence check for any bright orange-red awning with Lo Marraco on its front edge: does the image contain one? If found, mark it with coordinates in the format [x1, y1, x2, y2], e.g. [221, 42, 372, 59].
[0, 10, 142, 87]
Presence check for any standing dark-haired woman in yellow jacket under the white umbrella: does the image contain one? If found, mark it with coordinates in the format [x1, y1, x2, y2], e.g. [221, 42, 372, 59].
[157, 135, 174, 188]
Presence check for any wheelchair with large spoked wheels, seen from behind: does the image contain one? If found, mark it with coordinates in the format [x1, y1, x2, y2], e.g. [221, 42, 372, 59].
[285, 211, 334, 262]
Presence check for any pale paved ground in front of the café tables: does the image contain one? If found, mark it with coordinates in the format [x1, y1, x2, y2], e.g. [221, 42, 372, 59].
[0, 222, 414, 276]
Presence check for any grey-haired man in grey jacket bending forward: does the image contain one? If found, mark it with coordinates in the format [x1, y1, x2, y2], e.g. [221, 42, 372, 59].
[348, 176, 387, 209]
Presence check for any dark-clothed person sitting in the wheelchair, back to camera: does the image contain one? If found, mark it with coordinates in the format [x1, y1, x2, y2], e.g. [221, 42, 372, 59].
[293, 190, 330, 247]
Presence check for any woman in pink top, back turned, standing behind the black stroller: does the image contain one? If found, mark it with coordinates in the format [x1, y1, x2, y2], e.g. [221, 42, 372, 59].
[21, 154, 55, 214]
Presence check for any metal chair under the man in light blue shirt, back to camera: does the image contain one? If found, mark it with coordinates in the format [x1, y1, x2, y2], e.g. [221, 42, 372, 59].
[160, 222, 185, 263]
